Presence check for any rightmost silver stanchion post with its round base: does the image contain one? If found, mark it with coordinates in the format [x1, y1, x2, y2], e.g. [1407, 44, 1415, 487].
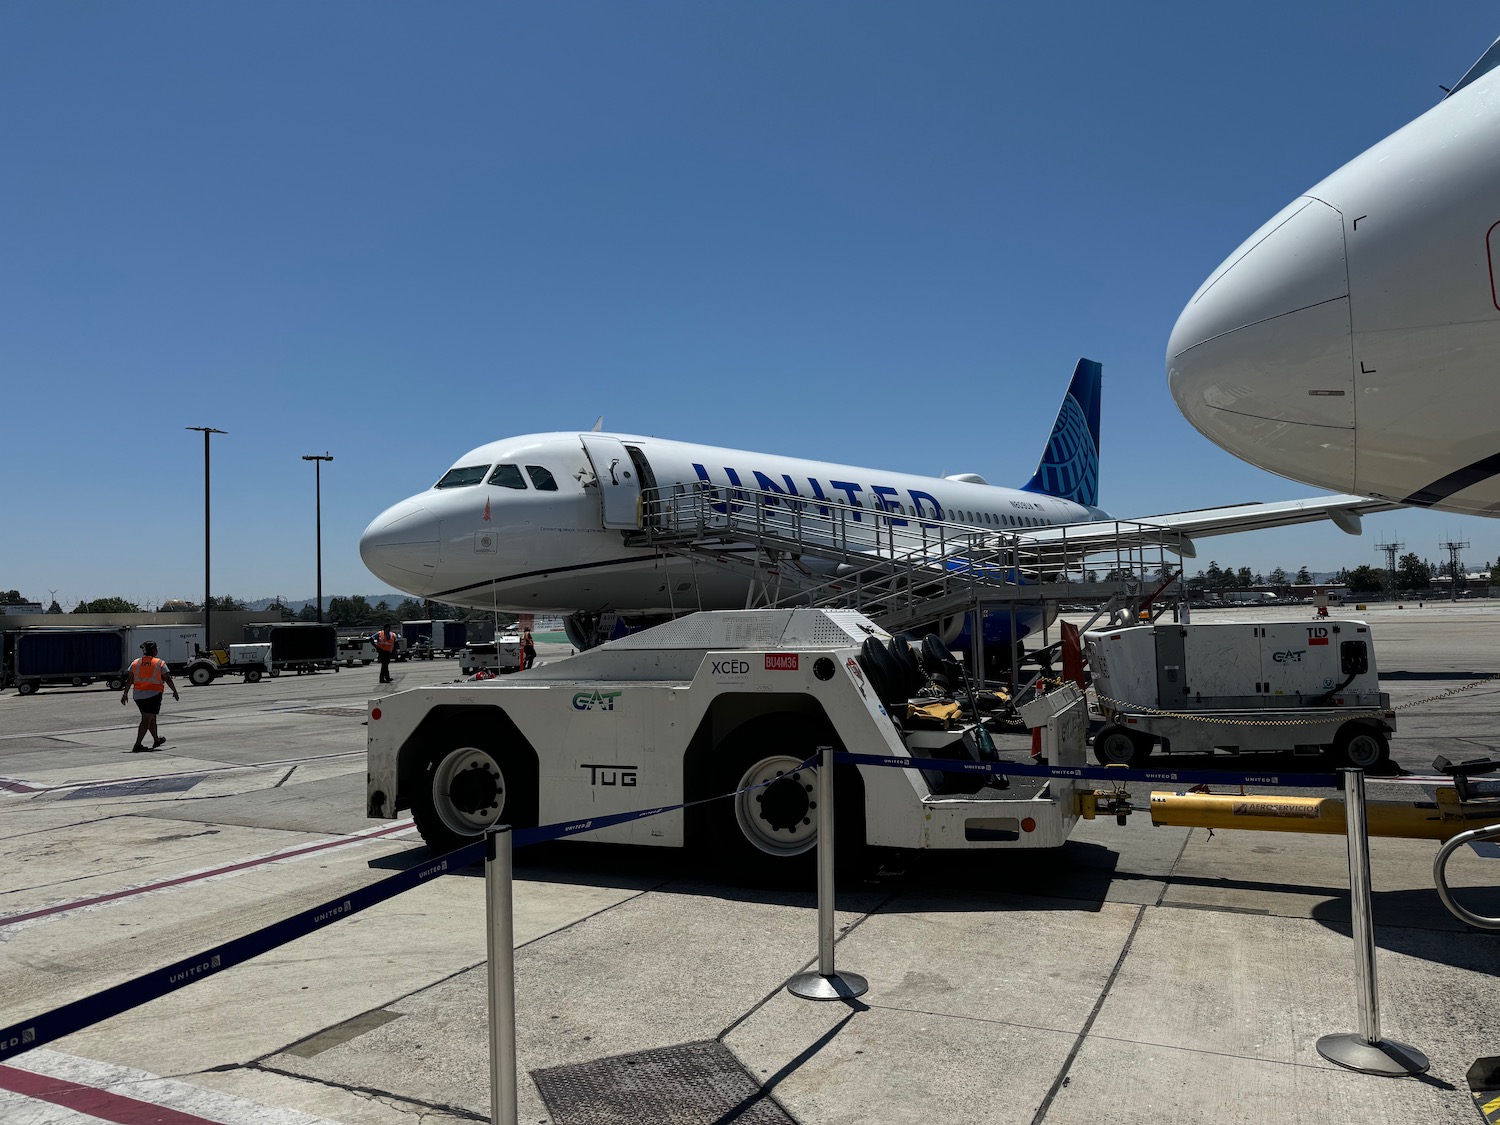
[1317, 768, 1431, 1079]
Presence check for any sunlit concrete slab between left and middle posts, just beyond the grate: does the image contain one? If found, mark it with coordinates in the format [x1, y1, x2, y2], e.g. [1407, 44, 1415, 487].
[263, 885, 882, 1119]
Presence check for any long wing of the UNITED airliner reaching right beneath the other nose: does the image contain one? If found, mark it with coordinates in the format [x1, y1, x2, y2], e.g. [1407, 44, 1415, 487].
[1026, 495, 1401, 558]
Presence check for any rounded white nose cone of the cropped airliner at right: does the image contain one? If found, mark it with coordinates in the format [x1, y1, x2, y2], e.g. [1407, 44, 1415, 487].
[1167, 197, 1355, 491]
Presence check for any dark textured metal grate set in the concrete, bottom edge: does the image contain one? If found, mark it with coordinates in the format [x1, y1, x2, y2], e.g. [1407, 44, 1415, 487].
[531, 1040, 795, 1125]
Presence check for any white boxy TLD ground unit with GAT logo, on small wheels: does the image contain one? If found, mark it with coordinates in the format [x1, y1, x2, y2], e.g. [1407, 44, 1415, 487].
[1083, 618, 1397, 770]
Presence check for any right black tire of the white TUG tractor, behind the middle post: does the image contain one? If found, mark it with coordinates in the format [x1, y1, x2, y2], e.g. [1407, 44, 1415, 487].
[702, 714, 864, 884]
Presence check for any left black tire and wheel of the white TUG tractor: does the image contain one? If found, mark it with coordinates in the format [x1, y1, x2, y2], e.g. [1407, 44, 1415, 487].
[411, 731, 537, 855]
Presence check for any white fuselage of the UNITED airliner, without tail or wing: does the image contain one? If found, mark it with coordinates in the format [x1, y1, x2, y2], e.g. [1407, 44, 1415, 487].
[360, 432, 1107, 615]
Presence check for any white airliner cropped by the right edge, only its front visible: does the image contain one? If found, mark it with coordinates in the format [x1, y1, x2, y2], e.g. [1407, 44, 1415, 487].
[1167, 31, 1500, 516]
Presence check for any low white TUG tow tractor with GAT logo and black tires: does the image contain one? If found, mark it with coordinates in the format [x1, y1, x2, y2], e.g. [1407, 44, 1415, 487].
[366, 609, 1086, 876]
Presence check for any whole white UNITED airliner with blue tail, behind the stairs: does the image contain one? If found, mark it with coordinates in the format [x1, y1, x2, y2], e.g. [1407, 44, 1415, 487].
[360, 360, 1391, 647]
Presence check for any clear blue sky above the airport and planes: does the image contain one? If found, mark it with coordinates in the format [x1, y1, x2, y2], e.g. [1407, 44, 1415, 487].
[0, 0, 1500, 605]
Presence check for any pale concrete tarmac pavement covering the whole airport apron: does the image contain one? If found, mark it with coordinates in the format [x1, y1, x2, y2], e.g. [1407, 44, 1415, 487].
[0, 605, 1500, 1125]
